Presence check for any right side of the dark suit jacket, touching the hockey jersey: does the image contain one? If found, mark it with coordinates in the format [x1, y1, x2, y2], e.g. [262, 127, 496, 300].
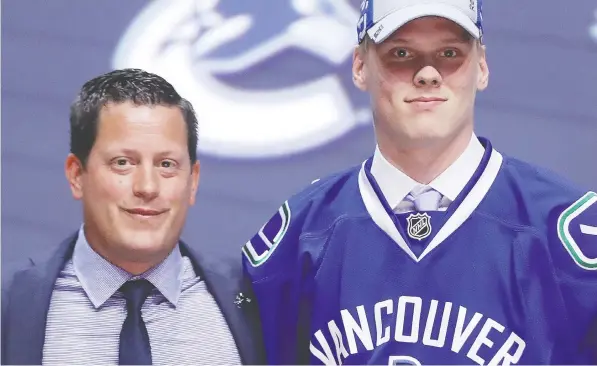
[181, 242, 265, 365]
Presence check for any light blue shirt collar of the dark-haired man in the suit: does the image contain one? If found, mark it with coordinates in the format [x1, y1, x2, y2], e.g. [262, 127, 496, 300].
[73, 225, 183, 309]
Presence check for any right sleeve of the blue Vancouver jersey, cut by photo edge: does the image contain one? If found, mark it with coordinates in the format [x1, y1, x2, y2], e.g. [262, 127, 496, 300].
[549, 192, 597, 361]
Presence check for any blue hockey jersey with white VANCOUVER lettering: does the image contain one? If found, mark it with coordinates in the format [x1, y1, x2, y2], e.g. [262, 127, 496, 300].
[243, 139, 597, 365]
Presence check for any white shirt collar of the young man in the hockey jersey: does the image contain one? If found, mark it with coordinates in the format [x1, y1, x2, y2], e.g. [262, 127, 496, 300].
[371, 134, 485, 209]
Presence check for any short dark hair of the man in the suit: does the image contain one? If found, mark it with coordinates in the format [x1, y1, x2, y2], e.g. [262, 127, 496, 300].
[70, 69, 198, 167]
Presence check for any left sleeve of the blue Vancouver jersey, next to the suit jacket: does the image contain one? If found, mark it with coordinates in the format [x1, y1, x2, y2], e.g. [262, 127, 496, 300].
[242, 200, 318, 365]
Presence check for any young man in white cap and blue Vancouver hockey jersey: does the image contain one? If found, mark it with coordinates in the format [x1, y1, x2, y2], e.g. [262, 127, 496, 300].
[243, 0, 597, 365]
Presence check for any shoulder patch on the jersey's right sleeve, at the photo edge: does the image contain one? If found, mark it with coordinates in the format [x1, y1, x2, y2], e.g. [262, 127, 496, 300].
[558, 192, 597, 270]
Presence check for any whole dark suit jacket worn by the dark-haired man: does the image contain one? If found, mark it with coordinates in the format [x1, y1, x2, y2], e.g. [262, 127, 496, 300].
[1, 233, 265, 365]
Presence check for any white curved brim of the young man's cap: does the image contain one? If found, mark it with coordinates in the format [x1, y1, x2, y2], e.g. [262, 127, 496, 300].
[367, 3, 480, 43]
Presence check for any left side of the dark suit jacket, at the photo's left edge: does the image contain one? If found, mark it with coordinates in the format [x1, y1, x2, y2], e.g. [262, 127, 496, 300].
[3, 233, 77, 365]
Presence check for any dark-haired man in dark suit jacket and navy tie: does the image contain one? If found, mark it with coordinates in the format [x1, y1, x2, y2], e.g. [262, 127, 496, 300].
[2, 69, 262, 364]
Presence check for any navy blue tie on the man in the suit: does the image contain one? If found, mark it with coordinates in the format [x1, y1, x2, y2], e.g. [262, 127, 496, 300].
[118, 280, 153, 365]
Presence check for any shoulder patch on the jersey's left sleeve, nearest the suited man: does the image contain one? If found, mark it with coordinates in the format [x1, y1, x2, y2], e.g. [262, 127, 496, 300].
[243, 201, 291, 267]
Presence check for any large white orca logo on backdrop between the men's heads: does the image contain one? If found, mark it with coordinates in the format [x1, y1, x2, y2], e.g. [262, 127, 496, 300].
[112, 0, 371, 158]
